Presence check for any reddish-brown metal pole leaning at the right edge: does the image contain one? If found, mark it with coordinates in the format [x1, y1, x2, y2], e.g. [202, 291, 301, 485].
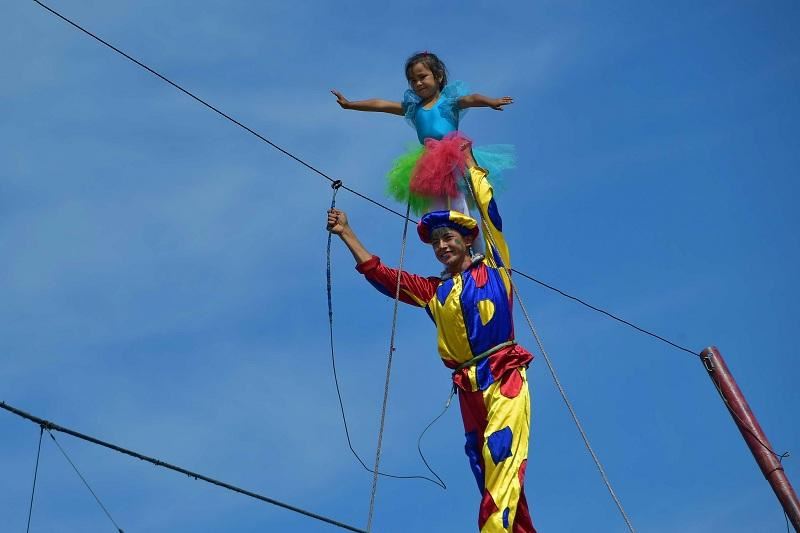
[700, 346, 800, 532]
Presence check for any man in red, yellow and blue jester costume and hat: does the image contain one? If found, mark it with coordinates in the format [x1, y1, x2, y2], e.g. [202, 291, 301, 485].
[328, 158, 536, 533]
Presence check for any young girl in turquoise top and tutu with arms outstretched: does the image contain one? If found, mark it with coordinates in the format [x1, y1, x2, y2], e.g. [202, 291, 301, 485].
[331, 52, 514, 215]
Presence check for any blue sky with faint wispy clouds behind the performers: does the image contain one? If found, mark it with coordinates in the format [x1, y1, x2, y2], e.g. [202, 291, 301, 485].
[0, 0, 800, 533]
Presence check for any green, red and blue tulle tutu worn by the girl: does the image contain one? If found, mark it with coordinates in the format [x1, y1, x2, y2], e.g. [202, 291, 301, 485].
[386, 131, 516, 215]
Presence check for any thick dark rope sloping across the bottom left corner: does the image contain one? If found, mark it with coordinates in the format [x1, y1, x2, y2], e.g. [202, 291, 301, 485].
[0, 402, 367, 533]
